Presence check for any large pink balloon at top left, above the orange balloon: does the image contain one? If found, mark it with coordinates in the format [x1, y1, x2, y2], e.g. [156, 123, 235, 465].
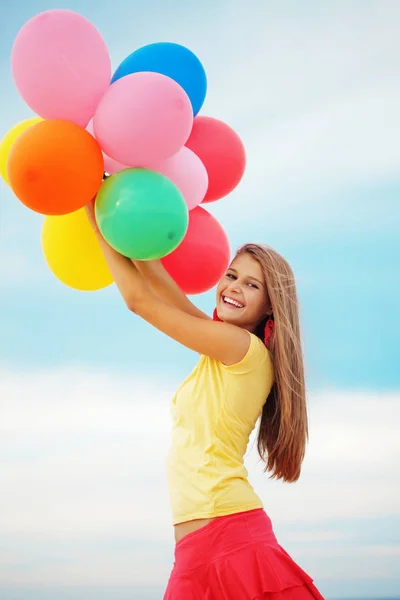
[11, 9, 111, 127]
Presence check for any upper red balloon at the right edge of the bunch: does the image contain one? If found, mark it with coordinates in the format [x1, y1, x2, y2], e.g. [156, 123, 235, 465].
[185, 116, 246, 203]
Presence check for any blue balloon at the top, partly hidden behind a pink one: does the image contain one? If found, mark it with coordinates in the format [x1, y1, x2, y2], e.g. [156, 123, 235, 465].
[111, 42, 207, 116]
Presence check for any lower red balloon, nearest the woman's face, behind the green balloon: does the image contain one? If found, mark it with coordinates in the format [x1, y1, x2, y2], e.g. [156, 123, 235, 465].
[162, 206, 231, 294]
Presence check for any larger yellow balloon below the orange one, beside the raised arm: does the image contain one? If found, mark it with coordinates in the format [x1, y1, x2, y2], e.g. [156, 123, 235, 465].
[42, 208, 113, 292]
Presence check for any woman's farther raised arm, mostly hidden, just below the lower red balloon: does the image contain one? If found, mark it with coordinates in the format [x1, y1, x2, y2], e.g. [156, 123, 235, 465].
[132, 260, 210, 320]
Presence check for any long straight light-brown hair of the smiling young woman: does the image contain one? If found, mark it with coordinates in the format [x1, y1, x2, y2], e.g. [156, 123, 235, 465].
[237, 244, 308, 482]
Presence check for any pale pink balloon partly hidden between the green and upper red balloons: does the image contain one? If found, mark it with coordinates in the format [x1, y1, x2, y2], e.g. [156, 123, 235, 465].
[146, 146, 208, 210]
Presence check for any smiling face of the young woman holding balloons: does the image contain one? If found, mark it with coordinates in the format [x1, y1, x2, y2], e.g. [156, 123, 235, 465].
[217, 252, 271, 332]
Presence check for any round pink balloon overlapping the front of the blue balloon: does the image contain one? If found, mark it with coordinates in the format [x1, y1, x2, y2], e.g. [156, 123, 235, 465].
[93, 72, 193, 167]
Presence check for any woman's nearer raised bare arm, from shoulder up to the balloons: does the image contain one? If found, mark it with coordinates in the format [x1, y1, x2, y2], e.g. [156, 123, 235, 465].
[86, 206, 250, 365]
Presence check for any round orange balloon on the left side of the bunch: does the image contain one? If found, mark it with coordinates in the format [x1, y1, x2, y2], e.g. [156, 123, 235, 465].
[7, 119, 104, 215]
